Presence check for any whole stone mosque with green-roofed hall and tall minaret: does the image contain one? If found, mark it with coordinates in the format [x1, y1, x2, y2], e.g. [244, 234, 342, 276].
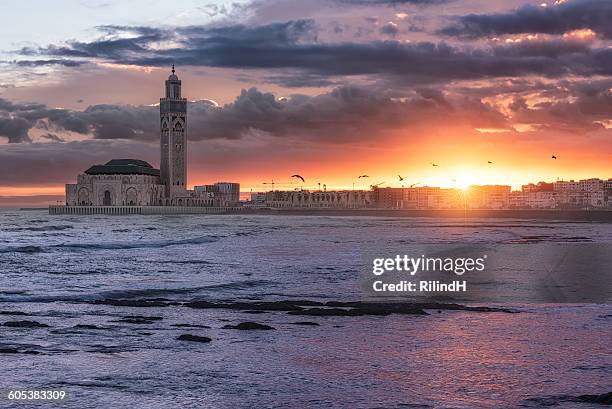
[65, 65, 240, 213]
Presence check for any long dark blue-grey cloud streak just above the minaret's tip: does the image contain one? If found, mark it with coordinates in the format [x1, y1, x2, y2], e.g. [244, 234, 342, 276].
[24, 20, 612, 86]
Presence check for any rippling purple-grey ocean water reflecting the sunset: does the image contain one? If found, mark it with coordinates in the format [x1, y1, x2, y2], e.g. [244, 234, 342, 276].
[0, 210, 612, 409]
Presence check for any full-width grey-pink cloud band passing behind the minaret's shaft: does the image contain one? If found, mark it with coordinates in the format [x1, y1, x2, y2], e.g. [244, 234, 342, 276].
[0, 75, 612, 143]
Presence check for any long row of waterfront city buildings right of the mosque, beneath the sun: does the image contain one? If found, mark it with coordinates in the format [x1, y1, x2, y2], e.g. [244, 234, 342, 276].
[260, 179, 612, 210]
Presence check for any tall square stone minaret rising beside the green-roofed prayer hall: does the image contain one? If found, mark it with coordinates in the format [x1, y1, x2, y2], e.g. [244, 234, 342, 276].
[159, 64, 187, 198]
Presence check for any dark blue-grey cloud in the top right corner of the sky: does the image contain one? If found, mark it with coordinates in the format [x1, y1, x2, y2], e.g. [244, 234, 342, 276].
[439, 0, 612, 39]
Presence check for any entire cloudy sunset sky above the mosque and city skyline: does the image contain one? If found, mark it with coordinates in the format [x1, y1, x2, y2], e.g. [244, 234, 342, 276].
[0, 0, 612, 206]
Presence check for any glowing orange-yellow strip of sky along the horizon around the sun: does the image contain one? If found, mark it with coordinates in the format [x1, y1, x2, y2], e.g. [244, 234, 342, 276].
[0, 126, 612, 202]
